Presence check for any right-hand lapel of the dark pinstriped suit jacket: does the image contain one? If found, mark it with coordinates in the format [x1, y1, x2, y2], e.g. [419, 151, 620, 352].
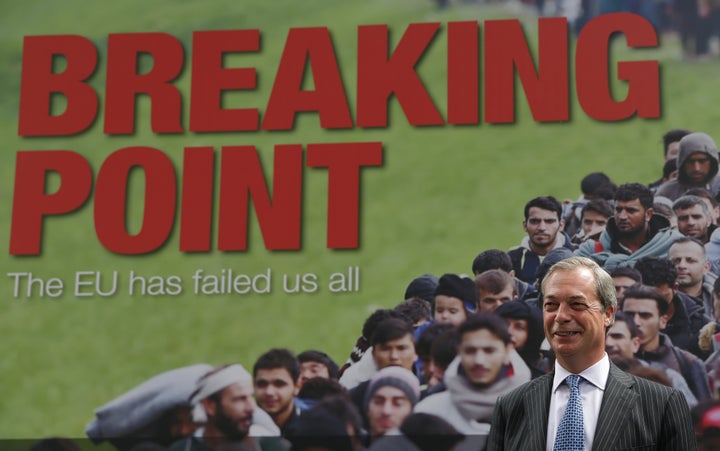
[592, 362, 639, 450]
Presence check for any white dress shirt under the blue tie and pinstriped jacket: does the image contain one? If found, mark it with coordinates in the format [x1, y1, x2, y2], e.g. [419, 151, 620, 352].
[546, 353, 610, 451]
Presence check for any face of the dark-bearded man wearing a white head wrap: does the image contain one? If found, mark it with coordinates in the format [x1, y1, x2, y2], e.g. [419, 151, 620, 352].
[203, 381, 255, 440]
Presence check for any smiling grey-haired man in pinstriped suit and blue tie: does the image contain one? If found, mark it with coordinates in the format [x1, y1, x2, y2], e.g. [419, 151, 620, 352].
[488, 257, 697, 451]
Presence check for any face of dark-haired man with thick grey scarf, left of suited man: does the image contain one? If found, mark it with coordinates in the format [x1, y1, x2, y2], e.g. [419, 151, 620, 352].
[458, 329, 512, 387]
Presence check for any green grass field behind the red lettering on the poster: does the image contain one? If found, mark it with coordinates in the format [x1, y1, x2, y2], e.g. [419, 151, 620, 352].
[0, 0, 720, 439]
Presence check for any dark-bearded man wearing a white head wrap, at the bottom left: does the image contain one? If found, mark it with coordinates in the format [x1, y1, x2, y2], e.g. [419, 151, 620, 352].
[170, 364, 288, 451]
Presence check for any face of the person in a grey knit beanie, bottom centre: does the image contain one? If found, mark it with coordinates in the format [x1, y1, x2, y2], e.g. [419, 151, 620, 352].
[368, 385, 412, 437]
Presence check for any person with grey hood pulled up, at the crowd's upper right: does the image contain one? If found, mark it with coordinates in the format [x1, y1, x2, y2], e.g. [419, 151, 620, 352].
[656, 132, 720, 201]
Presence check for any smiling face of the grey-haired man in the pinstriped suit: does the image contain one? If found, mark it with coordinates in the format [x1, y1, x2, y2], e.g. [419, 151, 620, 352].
[543, 268, 614, 373]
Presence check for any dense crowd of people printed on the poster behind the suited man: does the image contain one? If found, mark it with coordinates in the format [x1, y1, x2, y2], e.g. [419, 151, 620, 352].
[32, 130, 720, 451]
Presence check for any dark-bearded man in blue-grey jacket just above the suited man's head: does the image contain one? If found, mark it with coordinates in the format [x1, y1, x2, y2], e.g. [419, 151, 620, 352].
[575, 183, 682, 271]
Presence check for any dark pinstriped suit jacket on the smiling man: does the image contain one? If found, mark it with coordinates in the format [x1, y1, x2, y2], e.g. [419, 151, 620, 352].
[487, 363, 697, 451]
